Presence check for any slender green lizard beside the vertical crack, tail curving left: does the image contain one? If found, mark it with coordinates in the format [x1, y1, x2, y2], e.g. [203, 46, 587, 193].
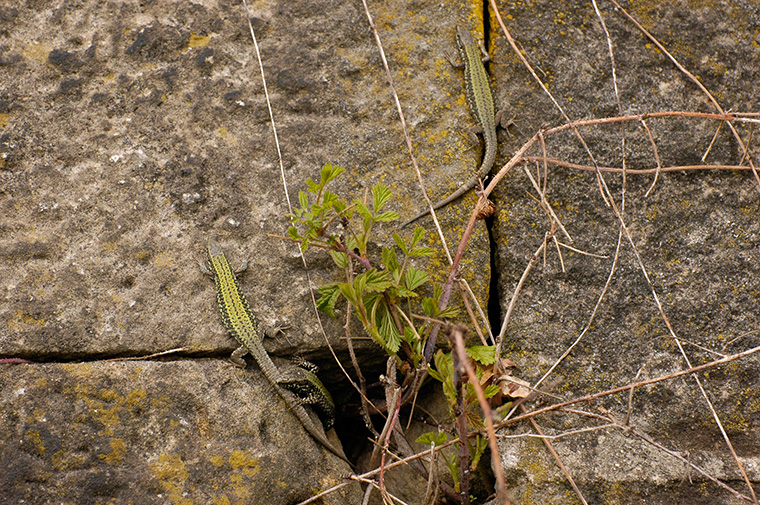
[402, 26, 501, 227]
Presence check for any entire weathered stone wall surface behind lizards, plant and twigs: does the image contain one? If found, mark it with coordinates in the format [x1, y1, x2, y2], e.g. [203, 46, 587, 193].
[0, 0, 760, 505]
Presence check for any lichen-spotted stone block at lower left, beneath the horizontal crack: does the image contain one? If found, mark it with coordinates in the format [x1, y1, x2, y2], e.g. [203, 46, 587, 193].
[0, 360, 356, 504]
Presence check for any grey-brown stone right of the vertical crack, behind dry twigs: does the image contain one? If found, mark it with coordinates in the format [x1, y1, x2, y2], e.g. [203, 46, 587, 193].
[492, 2, 760, 504]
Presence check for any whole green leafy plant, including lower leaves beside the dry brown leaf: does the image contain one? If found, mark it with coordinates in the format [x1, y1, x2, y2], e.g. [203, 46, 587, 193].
[288, 163, 516, 489]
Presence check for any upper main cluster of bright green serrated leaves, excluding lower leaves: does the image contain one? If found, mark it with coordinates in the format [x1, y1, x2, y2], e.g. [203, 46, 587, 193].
[288, 163, 458, 358]
